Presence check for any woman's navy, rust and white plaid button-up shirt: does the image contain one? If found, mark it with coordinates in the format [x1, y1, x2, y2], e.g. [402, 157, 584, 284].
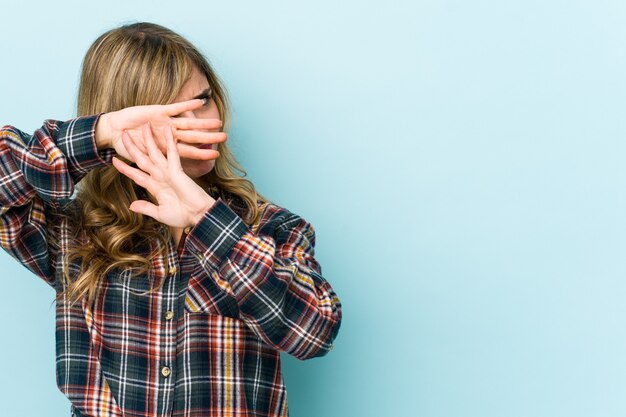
[0, 116, 341, 417]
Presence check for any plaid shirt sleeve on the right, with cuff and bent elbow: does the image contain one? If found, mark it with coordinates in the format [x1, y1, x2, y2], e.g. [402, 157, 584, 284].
[187, 198, 341, 359]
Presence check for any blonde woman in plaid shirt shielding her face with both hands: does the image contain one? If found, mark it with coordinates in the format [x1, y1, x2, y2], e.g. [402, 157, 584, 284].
[0, 23, 341, 416]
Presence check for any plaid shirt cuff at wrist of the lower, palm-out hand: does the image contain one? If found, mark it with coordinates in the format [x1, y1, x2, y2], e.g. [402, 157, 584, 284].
[186, 197, 250, 269]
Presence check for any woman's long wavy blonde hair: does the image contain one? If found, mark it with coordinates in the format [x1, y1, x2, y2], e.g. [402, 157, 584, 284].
[51, 22, 269, 305]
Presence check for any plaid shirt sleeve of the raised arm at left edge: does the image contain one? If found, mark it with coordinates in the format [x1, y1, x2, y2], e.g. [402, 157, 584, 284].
[0, 115, 115, 287]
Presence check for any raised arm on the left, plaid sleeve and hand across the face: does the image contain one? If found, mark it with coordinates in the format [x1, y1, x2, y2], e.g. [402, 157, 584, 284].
[0, 99, 219, 286]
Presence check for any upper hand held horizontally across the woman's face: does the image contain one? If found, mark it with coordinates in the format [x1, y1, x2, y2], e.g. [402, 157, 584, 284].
[96, 99, 227, 162]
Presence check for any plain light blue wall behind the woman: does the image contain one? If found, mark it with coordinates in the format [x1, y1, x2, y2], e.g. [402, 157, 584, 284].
[0, 0, 626, 417]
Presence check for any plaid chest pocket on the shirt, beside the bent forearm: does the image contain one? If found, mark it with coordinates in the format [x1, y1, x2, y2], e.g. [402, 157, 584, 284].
[185, 267, 239, 318]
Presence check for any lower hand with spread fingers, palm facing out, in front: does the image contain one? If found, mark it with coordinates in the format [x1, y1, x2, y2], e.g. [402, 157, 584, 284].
[113, 124, 215, 227]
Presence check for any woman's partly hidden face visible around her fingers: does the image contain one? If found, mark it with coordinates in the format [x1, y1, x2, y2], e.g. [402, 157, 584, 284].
[174, 67, 220, 180]
